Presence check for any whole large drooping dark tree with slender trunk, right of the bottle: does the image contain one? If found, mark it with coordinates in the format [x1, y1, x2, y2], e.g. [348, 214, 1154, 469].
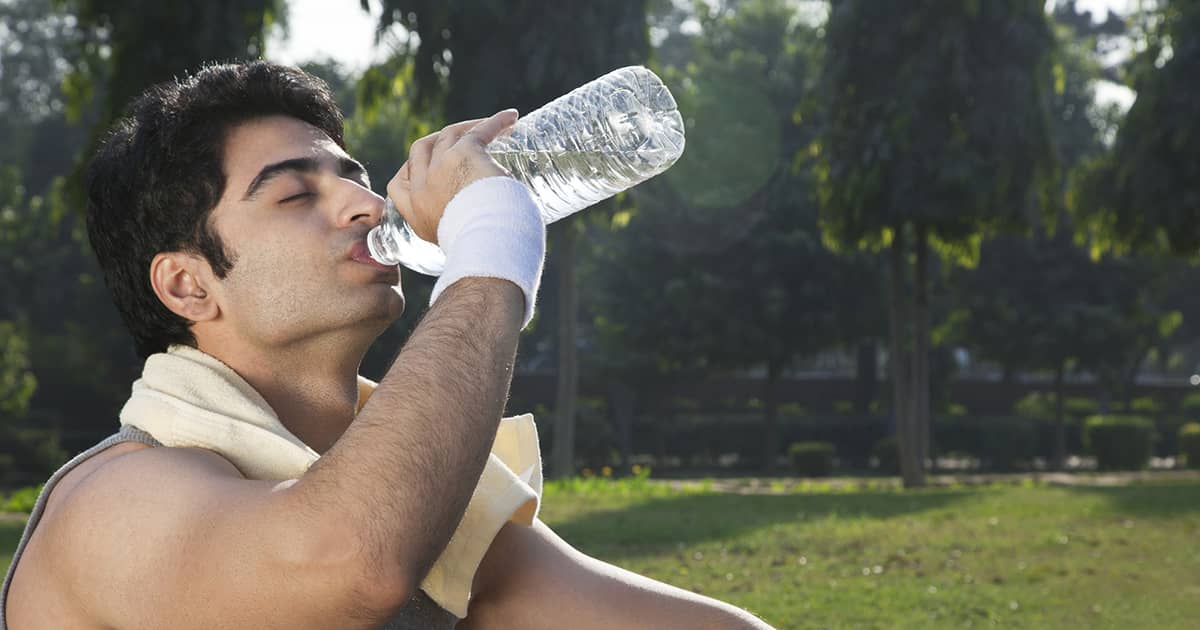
[814, 0, 1054, 487]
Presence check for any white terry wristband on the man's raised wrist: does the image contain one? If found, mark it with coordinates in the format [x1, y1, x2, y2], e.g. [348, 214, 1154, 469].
[430, 176, 546, 329]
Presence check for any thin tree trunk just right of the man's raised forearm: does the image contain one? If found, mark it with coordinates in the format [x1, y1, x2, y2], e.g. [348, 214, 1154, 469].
[551, 216, 580, 478]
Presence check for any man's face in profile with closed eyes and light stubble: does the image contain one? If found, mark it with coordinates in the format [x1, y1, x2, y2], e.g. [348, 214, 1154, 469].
[204, 116, 404, 346]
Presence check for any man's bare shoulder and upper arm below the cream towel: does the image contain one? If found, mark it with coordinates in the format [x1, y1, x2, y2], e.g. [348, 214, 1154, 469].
[7, 439, 396, 630]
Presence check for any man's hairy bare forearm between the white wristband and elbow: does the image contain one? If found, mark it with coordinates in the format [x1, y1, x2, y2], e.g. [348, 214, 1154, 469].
[292, 278, 524, 601]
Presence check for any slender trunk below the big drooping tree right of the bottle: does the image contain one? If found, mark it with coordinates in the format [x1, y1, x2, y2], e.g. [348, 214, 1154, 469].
[888, 226, 924, 487]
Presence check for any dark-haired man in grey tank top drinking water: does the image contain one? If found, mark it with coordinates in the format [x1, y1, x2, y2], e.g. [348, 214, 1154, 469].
[0, 62, 764, 630]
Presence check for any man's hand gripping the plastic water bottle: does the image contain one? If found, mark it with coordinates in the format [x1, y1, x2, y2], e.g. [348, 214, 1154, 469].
[388, 109, 517, 244]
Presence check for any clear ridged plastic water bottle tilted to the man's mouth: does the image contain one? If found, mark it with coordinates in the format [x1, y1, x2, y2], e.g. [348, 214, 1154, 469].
[367, 66, 684, 276]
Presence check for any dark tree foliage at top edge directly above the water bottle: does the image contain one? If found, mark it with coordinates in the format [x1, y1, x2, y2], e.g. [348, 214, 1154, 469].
[372, 0, 649, 120]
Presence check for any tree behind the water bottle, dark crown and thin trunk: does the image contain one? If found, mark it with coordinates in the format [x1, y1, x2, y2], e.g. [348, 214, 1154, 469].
[364, 0, 649, 476]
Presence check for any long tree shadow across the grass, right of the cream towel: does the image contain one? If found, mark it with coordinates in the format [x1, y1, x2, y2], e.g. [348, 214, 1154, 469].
[551, 491, 972, 548]
